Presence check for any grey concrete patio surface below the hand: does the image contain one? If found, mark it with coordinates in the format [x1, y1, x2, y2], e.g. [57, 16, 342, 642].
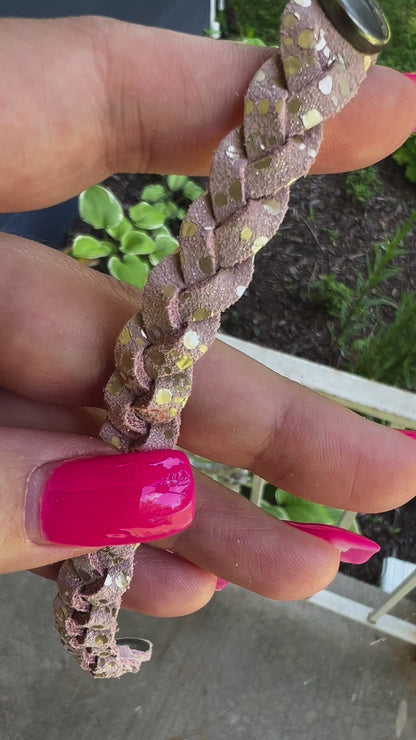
[0, 573, 416, 740]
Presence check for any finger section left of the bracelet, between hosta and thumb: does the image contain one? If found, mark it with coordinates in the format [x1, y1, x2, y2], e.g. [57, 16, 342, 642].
[0, 233, 141, 406]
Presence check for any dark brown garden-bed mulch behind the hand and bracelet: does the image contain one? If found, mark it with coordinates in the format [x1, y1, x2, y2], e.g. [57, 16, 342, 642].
[70, 159, 416, 583]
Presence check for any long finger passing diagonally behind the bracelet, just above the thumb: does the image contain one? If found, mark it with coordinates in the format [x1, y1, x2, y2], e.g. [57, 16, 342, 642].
[0, 240, 416, 511]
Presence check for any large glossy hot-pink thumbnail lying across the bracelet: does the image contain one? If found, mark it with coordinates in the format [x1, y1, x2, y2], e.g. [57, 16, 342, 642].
[25, 450, 194, 547]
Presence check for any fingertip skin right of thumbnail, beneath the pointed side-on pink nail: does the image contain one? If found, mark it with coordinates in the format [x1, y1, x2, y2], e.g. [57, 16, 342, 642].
[152, 471, 339, 600]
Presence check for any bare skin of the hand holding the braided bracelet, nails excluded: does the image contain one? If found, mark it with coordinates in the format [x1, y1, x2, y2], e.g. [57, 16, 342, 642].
[0, 18, 416, 616]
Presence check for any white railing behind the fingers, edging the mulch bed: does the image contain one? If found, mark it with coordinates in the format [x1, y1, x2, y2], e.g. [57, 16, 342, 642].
[218, 334, 416, 645]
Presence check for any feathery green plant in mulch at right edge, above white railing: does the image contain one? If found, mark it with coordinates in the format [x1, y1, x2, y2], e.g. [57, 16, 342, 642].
[307, 211, 416, 372]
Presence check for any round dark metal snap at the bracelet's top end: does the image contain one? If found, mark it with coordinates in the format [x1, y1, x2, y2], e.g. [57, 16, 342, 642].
[318, 0, 391, 54]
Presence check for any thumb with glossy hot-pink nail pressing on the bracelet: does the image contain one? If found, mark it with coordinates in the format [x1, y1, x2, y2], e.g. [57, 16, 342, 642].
[0, 428, 194, 573]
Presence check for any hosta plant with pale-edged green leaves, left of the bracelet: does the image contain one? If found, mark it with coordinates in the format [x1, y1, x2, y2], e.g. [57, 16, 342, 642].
[67, 175, 202, 289]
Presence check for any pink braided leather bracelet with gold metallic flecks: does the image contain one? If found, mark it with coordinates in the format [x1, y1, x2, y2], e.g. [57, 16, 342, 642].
[54, 0, 389, 678]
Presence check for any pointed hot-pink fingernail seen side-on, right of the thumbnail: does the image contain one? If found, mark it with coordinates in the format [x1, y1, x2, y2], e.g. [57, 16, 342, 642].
[285, 521, 380, 565]
